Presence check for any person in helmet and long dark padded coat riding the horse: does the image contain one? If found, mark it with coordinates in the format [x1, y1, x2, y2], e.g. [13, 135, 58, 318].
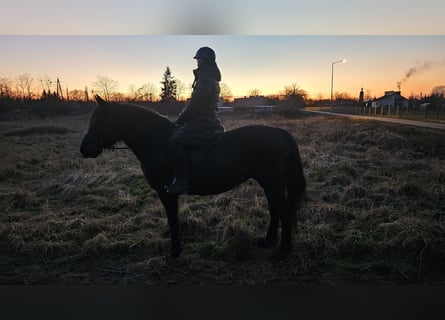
[166, 47, 224, 194]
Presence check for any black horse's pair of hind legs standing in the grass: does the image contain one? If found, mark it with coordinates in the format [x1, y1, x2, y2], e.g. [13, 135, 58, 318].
[265, 185, 291, 252]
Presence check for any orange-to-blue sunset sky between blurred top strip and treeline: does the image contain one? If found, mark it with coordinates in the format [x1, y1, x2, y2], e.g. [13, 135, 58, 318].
[0, 36, 445, 100]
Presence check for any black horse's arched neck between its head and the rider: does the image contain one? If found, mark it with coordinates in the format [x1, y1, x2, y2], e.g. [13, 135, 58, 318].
[113, 105, 174, 160]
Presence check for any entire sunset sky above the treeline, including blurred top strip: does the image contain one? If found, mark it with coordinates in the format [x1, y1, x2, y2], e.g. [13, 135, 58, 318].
[0, 0, 445, 98]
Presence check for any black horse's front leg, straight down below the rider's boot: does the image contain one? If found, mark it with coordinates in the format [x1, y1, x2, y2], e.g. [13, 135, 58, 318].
[158, 191, 182, 258]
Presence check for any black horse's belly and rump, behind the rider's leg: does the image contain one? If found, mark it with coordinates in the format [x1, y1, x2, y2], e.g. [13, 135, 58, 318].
[190, 125, 293, 194]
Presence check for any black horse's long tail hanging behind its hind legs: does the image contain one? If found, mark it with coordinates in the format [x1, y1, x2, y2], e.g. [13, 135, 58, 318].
[286, 132, 306, 226]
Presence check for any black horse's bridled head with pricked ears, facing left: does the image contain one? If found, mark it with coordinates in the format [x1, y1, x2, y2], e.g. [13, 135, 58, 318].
[80, 95, 118, 158]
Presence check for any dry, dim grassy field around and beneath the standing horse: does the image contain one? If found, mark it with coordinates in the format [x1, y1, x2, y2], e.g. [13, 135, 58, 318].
[0, 116, 445, 285]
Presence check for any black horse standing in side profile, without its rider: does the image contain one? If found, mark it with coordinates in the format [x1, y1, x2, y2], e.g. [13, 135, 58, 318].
[80, 96, 306, 256]
